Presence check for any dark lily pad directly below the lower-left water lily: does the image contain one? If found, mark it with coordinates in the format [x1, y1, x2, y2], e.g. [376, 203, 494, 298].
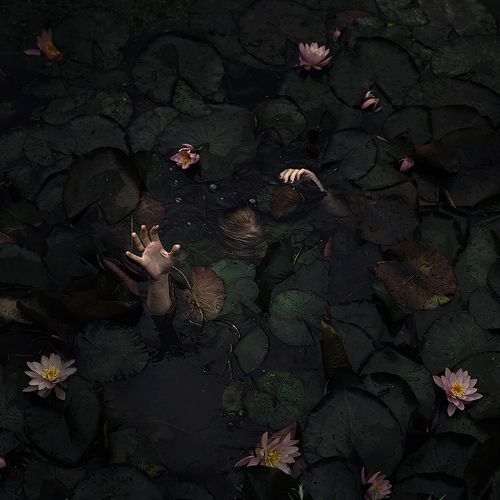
[25, 376, 101, 465]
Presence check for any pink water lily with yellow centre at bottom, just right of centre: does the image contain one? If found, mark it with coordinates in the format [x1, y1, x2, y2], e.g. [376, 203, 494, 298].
[235, 432, 300, 474]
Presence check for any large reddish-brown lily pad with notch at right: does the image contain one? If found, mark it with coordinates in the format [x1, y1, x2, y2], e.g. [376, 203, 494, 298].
[375, 241, 457, 310]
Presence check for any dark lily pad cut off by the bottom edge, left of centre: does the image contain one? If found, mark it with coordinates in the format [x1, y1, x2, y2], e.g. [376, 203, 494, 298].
[72, 465, 163, 500]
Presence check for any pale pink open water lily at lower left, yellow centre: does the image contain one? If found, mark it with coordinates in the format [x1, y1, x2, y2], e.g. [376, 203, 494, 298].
[23, 353, 76, 400]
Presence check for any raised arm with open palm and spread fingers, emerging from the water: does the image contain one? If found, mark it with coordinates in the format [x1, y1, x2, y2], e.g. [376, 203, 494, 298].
[125, 225, 181, 316]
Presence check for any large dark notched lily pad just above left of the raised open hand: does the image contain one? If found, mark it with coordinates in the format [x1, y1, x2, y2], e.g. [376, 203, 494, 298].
[63, 148, 140, 224]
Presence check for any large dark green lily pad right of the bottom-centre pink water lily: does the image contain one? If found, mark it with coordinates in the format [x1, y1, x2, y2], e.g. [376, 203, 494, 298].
[303, 388, 403, 474]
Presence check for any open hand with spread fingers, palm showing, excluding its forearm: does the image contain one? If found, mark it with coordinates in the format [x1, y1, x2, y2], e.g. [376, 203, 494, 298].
[125, 225, 181, 280]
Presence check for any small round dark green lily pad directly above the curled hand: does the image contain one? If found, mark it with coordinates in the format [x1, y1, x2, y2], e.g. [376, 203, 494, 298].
[256, 97, 306, 144]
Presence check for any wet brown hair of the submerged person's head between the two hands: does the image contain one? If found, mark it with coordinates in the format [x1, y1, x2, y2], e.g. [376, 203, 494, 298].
[218, 207, 263, 257]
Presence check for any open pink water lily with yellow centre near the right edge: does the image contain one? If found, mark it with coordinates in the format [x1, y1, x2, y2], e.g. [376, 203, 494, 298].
[432, 368, 483, 417]
